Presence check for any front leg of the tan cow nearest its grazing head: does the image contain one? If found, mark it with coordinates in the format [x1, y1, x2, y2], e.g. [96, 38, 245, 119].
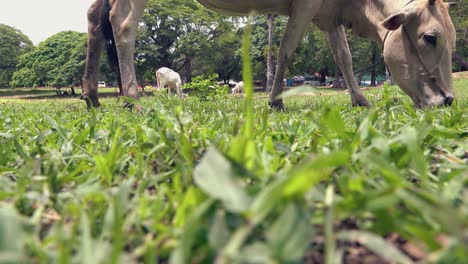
[327, 26, 370, 106]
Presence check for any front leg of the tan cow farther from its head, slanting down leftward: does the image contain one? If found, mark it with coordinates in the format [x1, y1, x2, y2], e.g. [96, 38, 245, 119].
[270, 0, 323, 109]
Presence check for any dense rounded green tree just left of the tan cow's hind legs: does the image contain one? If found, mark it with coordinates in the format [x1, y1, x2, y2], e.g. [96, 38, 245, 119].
[11, 31, 87, 87]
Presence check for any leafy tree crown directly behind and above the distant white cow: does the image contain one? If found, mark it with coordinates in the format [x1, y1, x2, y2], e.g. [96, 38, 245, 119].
[136, 0, 240, 82]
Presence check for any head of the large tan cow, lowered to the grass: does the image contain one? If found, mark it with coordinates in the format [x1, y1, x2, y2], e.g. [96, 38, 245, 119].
[382, 0, 456, 107]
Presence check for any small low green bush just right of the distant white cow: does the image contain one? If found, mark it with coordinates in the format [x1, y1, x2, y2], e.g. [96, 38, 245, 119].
[184, 74, 228, 101]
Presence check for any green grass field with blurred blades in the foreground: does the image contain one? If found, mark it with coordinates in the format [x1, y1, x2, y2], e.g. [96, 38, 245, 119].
[0, 79, 468, 263]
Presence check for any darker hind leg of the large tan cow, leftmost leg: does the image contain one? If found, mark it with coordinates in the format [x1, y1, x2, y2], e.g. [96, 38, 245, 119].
[81, 0, 104, 108]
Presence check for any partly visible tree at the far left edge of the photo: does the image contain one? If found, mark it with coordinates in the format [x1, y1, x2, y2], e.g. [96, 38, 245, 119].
[0, 24, 34, 87]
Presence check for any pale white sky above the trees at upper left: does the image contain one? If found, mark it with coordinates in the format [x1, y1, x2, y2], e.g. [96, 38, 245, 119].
[0, 0, 94, 45]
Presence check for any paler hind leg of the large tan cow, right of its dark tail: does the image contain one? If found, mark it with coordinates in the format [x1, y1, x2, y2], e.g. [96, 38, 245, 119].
[110, 0, 146, 105]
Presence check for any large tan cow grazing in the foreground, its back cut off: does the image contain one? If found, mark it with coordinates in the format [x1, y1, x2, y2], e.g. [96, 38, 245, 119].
[83, 0, 455, 108]
